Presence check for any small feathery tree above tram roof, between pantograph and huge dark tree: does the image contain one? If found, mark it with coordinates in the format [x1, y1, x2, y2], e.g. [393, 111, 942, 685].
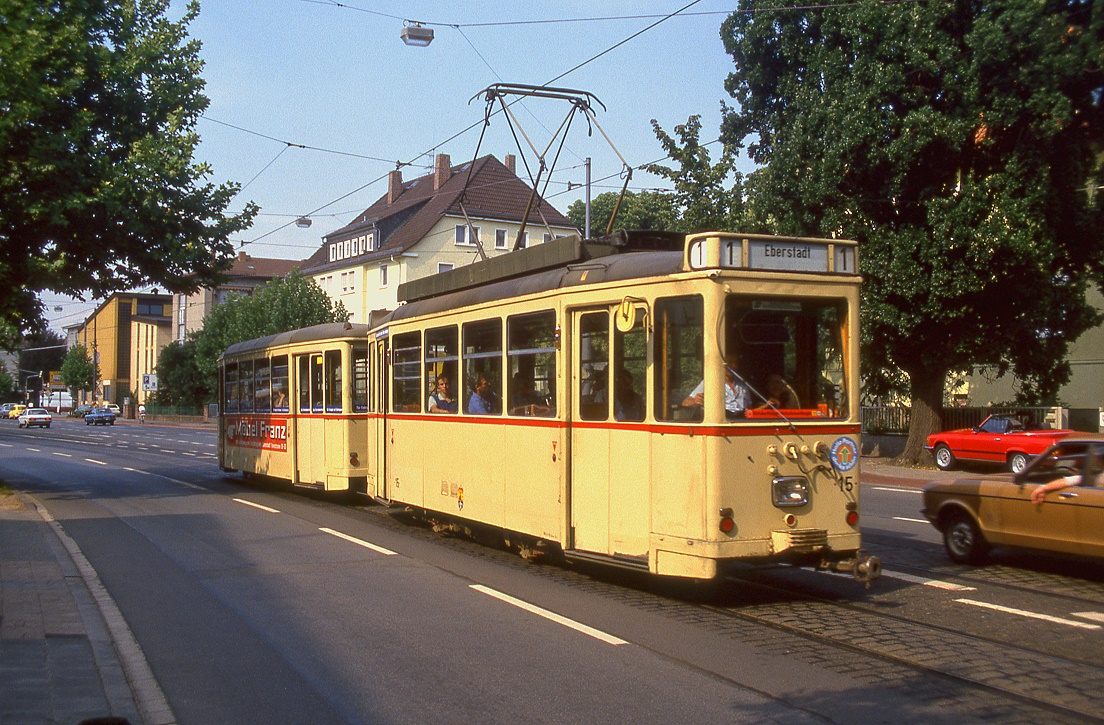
[646, 116, 745, 232]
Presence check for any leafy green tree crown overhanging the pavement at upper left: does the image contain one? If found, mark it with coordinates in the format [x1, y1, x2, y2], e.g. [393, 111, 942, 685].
[0, 0, 257, 332]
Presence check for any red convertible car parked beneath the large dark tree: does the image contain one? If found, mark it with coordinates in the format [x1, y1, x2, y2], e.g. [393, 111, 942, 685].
[924, 415, 1075, 473]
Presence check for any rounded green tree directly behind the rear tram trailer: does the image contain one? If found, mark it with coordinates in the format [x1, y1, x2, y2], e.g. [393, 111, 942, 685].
[178, 269, 349, 401]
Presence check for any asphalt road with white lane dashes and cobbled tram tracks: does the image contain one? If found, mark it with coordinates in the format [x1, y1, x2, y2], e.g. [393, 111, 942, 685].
[0, 419, 1104, 723]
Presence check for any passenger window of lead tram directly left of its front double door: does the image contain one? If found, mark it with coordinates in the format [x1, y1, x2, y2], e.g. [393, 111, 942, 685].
[506, 310, 556, 417]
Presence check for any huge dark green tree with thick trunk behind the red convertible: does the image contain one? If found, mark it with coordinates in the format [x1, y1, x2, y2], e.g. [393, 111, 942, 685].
[721, 0, 1104, 462]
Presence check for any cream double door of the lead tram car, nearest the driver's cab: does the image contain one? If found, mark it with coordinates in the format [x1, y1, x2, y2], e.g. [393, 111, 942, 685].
[571, 309, 650, 557]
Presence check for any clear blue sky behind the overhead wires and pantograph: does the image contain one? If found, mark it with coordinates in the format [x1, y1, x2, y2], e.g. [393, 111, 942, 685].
[43, 0, 746, 330]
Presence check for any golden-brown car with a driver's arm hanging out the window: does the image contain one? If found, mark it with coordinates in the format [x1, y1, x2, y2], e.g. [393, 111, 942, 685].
[923, 434, 1104, 564]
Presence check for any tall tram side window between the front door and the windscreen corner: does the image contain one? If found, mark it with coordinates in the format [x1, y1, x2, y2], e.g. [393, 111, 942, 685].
[652, 297, 705, 420]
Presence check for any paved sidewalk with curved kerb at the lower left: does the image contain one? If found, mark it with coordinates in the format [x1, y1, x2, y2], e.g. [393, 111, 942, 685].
[0, 491, 142, 725]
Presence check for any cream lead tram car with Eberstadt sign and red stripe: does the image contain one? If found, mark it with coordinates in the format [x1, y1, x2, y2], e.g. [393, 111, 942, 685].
[221, 232, 879, 579]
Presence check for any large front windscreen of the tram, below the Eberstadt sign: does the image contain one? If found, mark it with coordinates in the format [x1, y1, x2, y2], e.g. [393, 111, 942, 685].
[724, 295, 847, 418]
